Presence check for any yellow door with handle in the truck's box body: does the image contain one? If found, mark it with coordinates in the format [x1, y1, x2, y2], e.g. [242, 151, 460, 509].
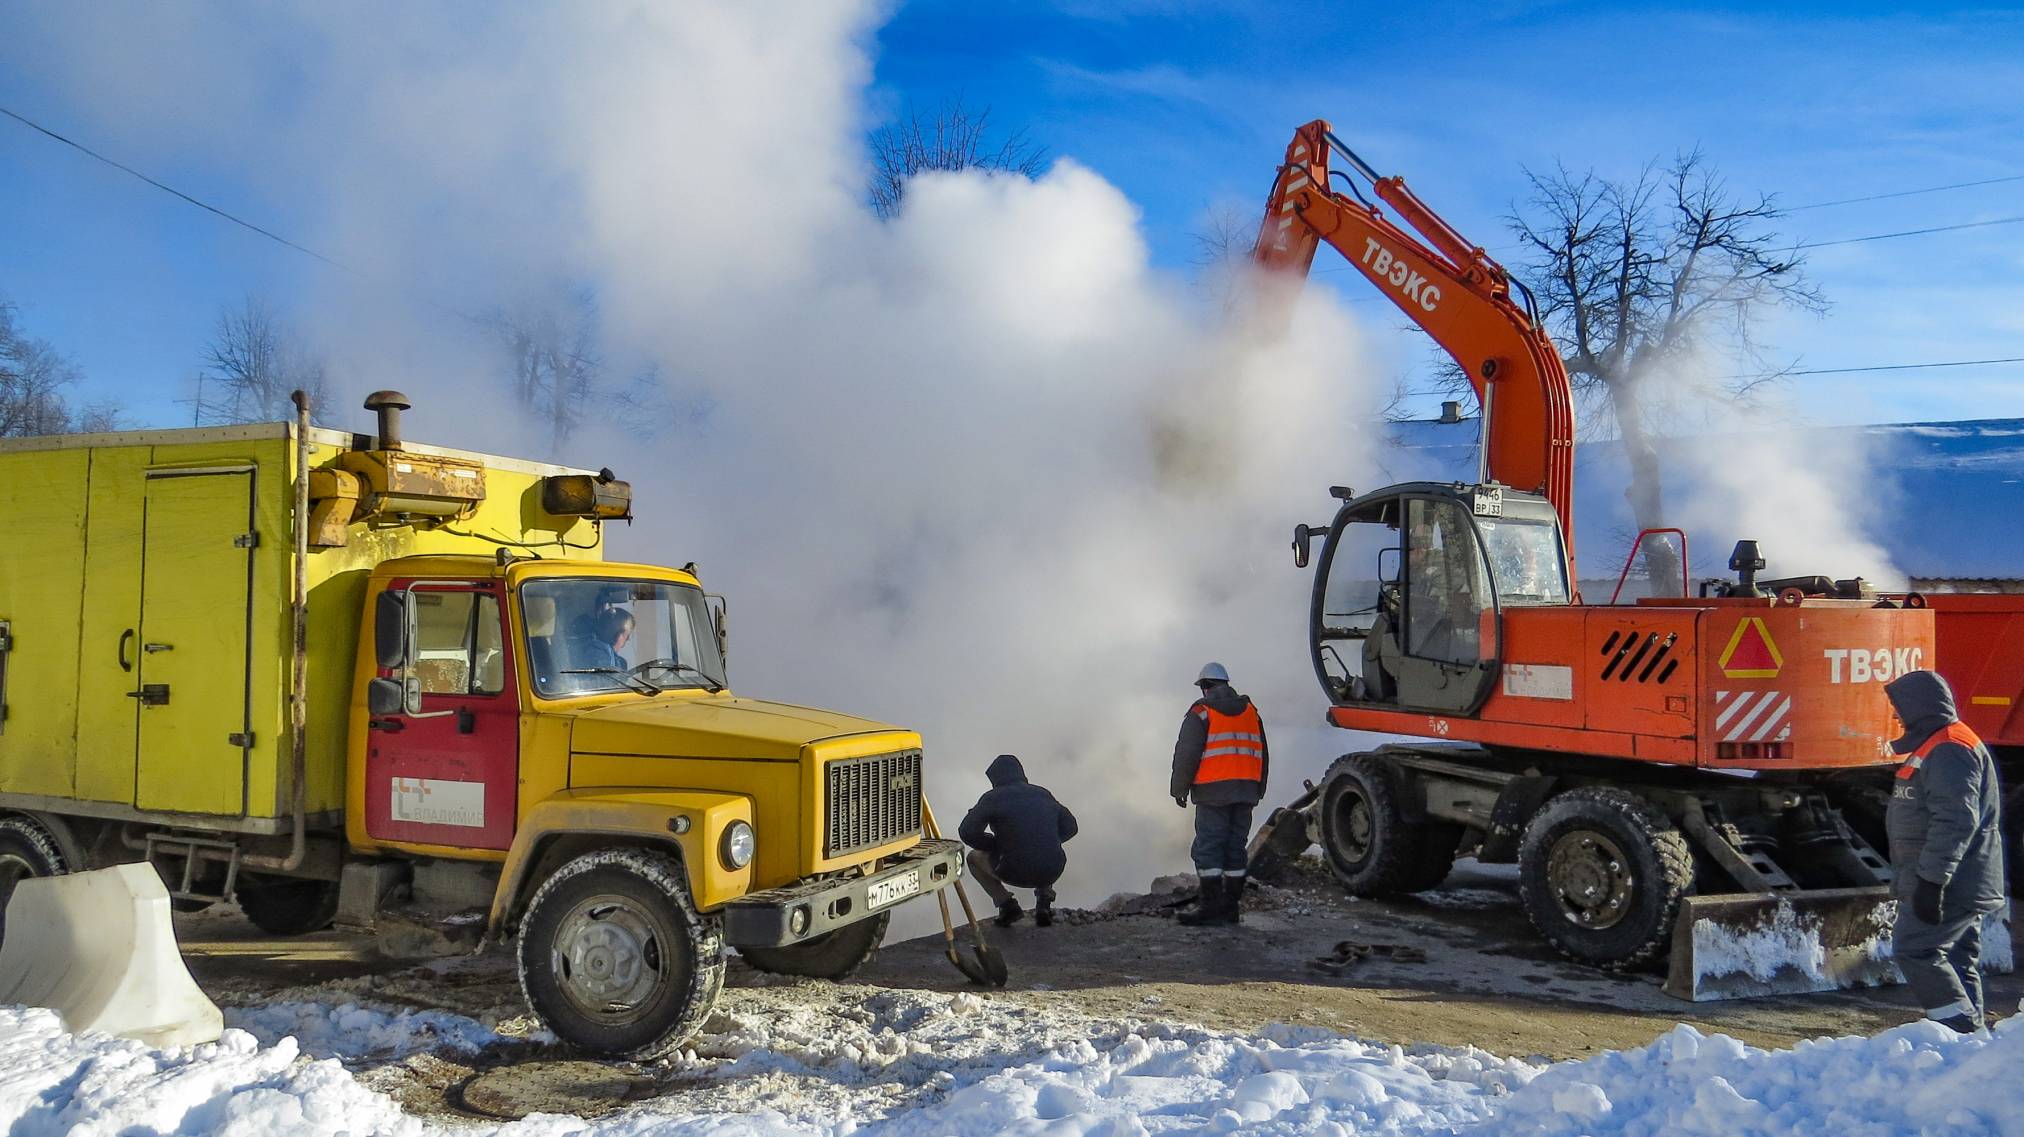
[134, 467, 255, 815]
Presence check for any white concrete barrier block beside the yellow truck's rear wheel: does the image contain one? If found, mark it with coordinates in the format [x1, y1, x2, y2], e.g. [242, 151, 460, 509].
[0, 864, 225, 1046]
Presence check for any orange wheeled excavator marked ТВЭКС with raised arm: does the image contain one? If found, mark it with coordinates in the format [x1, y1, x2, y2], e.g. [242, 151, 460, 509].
[1253, 121, 1933, 997]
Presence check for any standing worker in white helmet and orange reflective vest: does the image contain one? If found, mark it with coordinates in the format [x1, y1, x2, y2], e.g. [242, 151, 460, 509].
[1172, 664, 1271, 927]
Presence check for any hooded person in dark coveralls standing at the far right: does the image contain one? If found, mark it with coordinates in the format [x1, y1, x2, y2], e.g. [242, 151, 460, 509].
[1884, 672, 2004, 1034]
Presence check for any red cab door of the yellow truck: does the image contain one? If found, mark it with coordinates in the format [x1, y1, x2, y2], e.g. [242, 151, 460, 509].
[366, 581, 520, 850]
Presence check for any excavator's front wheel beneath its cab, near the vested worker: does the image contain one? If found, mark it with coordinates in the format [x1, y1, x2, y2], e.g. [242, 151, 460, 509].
[1322, 755, 1461, 896]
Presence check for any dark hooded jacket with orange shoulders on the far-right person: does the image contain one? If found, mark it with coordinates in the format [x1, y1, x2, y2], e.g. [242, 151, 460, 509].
[1884, 672, 2004, 914]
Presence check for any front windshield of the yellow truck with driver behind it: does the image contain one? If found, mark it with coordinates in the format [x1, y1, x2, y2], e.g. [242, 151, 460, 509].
[520, 577, 725, 698]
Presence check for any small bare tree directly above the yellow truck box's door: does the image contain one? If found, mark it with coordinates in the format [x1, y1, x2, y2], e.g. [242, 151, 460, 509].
[196, 295, 330, 423]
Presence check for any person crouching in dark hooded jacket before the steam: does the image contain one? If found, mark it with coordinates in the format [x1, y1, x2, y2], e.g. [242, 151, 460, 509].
[955, 755, 1075, 929]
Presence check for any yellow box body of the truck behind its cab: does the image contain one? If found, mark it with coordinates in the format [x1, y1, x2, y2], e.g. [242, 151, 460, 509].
[0, 423, 601, 834]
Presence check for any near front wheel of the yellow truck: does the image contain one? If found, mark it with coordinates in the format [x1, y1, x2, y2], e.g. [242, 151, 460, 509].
[518, 850, 725, 1062]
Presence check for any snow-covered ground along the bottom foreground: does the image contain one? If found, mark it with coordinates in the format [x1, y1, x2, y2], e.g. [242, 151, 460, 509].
[0, 985, 2024, 1137]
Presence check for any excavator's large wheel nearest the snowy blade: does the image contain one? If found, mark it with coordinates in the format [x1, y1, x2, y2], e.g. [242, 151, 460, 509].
[1518, 787, 1694, 971]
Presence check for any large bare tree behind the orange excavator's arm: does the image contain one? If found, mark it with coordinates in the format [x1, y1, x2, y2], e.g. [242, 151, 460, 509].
[1506, 150, 1826, 583]
